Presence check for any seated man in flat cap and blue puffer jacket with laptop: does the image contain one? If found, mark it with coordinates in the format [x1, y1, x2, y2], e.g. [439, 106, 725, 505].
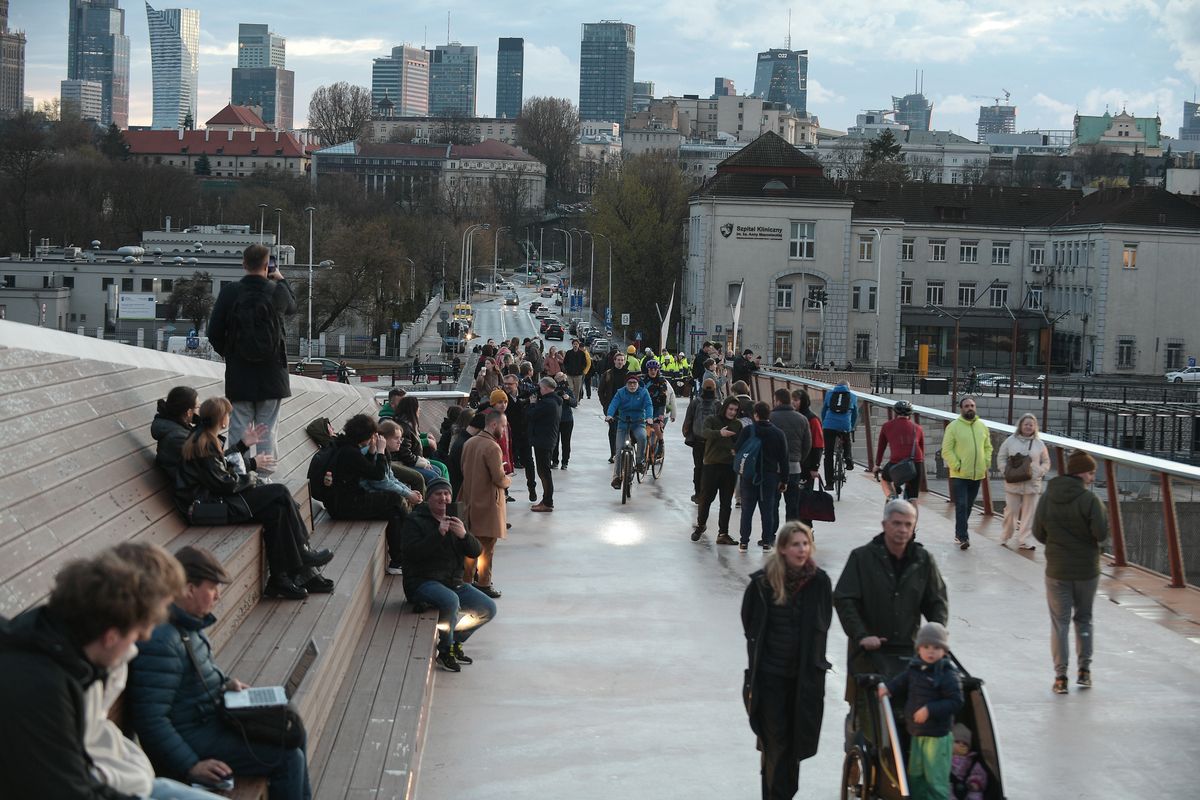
[126, 547, 312, 800]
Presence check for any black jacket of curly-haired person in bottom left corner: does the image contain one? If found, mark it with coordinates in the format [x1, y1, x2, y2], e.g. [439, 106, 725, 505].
[0, 607, 136, 800]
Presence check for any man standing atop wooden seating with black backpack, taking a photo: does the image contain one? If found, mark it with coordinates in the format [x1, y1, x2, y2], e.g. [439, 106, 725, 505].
[208, 245, 296, 471]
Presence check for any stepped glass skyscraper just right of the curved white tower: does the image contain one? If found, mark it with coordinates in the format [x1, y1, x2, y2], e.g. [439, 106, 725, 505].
[229, 23, 295, 131]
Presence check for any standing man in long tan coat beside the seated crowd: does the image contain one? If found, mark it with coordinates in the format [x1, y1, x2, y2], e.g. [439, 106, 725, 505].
[458, 410, 510, 599]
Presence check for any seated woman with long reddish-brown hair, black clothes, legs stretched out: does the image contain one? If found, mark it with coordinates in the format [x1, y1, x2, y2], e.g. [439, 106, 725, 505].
[175, 397, 334, 600]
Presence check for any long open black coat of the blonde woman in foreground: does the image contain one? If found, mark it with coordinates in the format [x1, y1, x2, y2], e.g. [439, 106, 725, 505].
[742, 569, 833, 759]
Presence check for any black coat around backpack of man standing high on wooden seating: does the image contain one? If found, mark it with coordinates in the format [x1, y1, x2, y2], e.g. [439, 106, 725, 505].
[209, 275, 296, 401]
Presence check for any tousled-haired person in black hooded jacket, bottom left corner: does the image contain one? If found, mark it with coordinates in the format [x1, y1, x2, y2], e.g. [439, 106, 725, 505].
[0, 551, 182, 800]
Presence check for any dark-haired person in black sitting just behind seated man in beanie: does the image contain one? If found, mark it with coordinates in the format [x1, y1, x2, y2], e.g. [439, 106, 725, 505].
[325, 412, 412, 575]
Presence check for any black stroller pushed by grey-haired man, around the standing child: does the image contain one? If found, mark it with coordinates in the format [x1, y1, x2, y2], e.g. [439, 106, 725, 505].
[841, 652, 1004, 800]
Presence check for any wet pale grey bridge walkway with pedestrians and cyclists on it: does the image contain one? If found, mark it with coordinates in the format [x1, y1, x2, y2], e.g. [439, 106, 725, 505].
[419, 293, 1200, 800]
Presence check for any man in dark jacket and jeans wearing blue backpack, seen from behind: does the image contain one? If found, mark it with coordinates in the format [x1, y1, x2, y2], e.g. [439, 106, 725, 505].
[733, 402, 787, 553]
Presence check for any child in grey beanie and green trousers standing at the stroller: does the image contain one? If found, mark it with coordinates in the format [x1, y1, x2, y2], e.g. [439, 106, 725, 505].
[880, 622, 962, 800]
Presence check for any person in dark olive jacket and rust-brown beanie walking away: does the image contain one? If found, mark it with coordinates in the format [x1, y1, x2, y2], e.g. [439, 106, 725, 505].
[1033, 450, 1109, 694]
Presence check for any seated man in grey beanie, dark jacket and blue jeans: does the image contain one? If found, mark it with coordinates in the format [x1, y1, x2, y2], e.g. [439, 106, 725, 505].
[401, 477, 496, 672]
